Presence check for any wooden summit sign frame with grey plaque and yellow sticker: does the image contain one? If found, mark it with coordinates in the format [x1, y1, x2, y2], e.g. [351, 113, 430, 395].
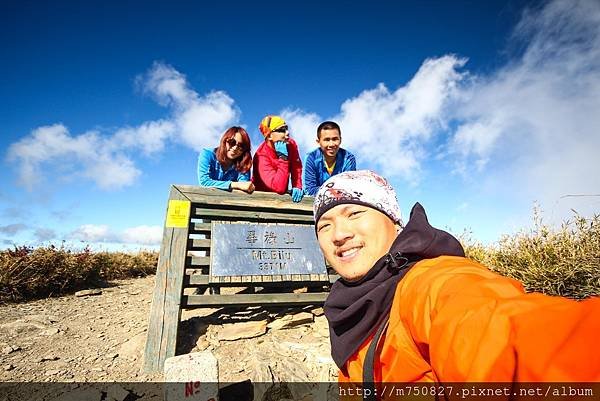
[144, 185, 337, 372]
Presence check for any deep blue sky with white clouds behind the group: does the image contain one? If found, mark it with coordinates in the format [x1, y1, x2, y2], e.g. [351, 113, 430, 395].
[0, 0, 600, 249]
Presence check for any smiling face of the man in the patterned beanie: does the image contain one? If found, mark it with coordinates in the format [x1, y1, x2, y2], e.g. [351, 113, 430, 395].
[317, 204, 398, 281]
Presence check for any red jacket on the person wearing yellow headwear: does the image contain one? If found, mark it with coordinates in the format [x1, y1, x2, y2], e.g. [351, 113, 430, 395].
[252, 138, 302, 194]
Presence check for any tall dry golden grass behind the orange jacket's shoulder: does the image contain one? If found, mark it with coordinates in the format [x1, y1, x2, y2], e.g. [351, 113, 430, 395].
[463, 209, 600, 299]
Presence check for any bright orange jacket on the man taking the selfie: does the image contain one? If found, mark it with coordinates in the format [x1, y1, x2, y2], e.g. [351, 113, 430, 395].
[339, 256, 600, 384]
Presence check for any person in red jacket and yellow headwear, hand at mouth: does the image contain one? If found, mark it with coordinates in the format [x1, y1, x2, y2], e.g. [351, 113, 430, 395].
[252, 116, 304, 202]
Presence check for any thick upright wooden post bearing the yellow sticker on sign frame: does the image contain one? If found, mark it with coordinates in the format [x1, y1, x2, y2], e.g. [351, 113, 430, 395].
[143, 186, 189, 373]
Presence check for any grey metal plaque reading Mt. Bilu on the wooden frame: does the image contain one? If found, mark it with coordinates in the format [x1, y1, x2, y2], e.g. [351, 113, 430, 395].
[210, 222, 327, 276]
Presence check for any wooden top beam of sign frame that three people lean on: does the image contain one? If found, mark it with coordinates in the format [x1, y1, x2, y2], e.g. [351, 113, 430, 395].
[176, 185, 314, 214]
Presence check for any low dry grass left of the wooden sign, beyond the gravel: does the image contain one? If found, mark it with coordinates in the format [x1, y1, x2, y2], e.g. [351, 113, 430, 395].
[0, 245, 158, 302]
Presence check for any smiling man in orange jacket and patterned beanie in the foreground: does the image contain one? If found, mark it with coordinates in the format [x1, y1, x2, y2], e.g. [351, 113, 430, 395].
[314, 170, 600, 385]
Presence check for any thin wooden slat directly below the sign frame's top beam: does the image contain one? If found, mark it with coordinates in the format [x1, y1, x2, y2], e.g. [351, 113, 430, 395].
[192, 207, 314, 225]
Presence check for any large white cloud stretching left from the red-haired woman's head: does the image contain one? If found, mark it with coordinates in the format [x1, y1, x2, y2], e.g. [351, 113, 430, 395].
[7, 63, 239, 190]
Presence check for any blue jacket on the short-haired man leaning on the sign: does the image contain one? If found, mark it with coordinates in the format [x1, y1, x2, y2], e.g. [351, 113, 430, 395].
[304, 148, 356, 196]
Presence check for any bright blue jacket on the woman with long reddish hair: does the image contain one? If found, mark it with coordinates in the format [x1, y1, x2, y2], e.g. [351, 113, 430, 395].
[198, 149, 250, 190]
